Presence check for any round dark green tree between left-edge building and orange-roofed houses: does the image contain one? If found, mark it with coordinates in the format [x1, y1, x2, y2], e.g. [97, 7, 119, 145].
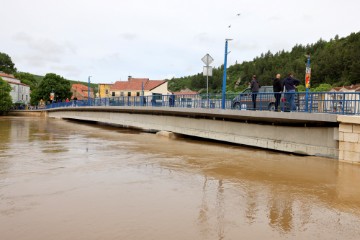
[31, 73, 72, 104]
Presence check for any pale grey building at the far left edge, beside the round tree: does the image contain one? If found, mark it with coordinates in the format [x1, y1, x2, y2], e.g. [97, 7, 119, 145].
[0, 72, 30, 105]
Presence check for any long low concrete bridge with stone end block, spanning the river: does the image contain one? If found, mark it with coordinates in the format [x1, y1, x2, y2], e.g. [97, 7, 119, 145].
[12, 106, 360, 163]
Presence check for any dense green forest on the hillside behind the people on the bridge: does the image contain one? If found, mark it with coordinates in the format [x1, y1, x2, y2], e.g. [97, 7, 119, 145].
[169, 32, 360, 93]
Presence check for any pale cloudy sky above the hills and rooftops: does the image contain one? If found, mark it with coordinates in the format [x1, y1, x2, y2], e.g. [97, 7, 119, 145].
[0, 0, 360, 83]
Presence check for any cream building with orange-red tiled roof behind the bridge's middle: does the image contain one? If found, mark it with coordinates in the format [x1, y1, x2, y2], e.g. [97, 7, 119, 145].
[110, 77, 171, 97]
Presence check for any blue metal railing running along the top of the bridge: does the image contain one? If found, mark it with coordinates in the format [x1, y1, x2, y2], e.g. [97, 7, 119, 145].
[46, 92, 360, 115]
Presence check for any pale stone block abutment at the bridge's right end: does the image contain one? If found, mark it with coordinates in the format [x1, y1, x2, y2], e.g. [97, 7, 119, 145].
[338, 115, 360, 163]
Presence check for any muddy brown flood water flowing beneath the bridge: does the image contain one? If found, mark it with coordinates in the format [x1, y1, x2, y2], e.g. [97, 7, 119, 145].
[0, 117, 360, 240]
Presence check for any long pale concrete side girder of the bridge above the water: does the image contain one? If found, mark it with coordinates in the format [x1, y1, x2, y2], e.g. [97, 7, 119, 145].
[48, 107, 339, 158]
